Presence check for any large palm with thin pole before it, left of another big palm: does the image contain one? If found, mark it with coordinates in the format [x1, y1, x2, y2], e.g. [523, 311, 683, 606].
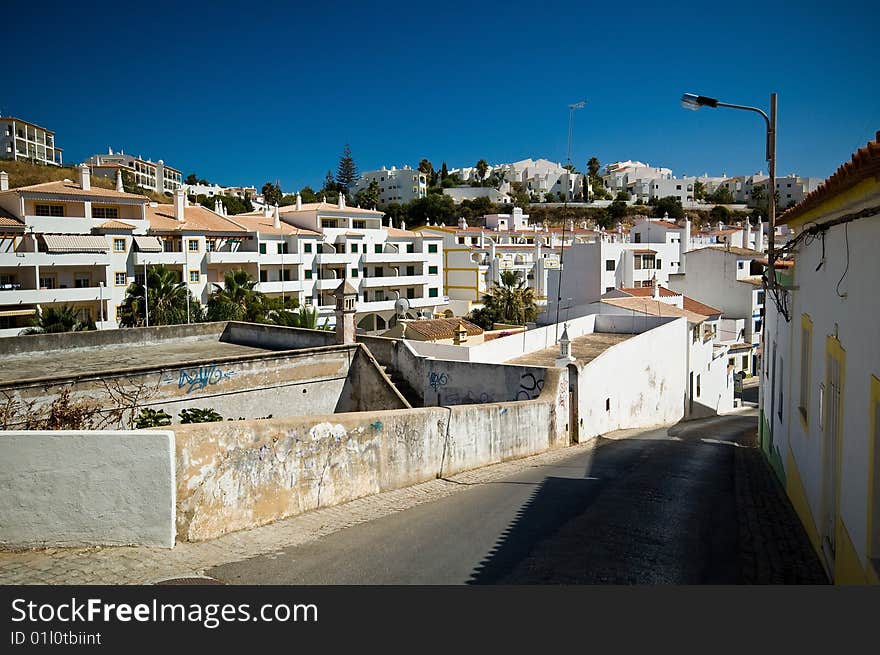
[119, 264, 202, 327]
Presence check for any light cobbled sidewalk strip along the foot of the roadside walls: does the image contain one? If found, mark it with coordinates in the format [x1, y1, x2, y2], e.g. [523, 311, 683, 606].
[0, 441, 595, 585]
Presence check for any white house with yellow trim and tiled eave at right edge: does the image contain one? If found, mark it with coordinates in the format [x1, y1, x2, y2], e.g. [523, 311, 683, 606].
[760, 132, 880, 584]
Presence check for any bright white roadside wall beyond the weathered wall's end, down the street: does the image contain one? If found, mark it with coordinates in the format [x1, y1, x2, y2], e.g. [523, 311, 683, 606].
[578, 316, 687, 441]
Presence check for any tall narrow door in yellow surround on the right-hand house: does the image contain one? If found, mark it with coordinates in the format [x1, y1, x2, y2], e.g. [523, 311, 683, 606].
[820, 339, 843, 571]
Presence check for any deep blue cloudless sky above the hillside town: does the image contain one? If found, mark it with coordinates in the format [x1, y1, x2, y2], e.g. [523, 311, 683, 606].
[0, 0, 880, 191]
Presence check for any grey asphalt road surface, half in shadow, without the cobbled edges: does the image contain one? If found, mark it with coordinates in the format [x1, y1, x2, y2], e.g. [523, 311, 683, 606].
[206, 416, 768, 585]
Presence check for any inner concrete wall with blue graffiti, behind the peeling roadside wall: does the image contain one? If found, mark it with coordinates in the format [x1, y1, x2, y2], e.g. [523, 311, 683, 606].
[0, 344, 407, 429]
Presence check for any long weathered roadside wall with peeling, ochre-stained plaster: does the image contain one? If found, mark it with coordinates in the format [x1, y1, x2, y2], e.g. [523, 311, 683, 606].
[175, 369, 568, 540]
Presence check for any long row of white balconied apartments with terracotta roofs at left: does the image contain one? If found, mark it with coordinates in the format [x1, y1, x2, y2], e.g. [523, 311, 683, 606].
[0, 165, 447, 336]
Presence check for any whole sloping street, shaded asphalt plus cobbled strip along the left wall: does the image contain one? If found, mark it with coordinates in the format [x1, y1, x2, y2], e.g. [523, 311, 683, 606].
[0, 411, 825, 584]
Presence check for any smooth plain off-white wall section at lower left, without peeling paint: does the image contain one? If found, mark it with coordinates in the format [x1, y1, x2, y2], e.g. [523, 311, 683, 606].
[0, 430, 175, 548]
